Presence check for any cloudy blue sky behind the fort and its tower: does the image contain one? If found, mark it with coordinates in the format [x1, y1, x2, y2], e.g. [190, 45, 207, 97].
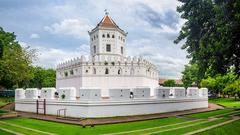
[0, 0, 188, 79]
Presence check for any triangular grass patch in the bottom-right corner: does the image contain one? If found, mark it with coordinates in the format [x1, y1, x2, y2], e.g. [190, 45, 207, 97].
[197, 120, 240, 135]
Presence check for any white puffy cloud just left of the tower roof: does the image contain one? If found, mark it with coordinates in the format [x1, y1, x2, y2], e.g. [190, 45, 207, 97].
[44, 19, 93, 38]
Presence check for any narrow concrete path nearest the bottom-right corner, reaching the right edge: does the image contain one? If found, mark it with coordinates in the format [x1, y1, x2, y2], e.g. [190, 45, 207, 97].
[184, 117, 240, 135]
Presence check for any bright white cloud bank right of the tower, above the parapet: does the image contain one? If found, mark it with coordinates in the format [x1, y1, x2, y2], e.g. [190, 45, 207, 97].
[127, 39, 188, 79]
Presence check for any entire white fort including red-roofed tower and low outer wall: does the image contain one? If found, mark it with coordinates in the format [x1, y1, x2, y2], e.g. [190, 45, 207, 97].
[15, 14, 208, 117]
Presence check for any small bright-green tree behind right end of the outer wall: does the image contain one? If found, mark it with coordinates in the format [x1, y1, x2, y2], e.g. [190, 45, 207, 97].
[182, 64, 200, 87]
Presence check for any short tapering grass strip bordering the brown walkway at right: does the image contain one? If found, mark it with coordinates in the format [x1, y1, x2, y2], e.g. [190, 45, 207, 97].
[186, 109, 233, 119]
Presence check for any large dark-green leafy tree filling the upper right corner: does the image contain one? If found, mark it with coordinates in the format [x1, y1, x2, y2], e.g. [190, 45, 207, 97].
[174, 0, 240, 78]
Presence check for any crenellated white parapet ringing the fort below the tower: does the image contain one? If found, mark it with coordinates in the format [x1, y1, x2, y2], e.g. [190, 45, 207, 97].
[57, 56, 158, 79]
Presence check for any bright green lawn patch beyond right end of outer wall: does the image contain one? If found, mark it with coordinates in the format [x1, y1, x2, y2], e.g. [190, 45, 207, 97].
[209, 98, 240, 108]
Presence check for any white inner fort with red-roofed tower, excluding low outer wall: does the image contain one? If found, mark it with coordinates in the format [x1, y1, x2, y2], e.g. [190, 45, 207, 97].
[56, 15, 159, 97]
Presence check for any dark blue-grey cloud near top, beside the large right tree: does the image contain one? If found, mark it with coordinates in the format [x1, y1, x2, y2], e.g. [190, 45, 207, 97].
[136, 3, 179, 29]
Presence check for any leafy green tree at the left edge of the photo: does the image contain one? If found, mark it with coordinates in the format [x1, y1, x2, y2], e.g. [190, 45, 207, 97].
[0, 27, 35, 88]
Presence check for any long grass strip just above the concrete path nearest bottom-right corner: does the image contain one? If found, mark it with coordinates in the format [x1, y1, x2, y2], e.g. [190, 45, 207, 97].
[150, 118, 229, 135]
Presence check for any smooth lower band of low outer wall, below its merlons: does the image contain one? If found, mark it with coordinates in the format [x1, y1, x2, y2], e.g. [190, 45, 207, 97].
[15, 98, 208, 117]
